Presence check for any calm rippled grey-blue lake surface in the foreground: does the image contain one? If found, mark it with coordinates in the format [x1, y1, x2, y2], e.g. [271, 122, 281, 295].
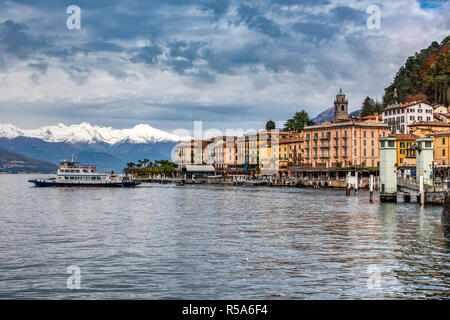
[0, 175, 450, 299]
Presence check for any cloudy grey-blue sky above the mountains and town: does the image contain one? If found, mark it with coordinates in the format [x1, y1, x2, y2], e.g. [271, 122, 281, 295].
[0, 0, 450, 131]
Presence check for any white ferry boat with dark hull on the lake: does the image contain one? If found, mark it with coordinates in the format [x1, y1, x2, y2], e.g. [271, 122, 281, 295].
[28, 159, 141, 187]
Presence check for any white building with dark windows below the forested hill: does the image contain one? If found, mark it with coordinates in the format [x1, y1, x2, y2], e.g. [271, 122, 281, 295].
[382, 101, 434, 133]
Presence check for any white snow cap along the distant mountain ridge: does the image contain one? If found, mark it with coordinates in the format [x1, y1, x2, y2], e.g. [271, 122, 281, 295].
[0, 122, 191, 145]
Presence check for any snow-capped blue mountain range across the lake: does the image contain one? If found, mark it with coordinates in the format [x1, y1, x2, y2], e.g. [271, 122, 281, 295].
[0, 122, 190, 172]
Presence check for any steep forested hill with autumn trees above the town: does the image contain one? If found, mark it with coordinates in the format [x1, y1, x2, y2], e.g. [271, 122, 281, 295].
[383, 36, 450, 106]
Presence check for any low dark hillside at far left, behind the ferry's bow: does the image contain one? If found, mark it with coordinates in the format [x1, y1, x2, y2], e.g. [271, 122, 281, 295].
[0, 150, 57, 173]
